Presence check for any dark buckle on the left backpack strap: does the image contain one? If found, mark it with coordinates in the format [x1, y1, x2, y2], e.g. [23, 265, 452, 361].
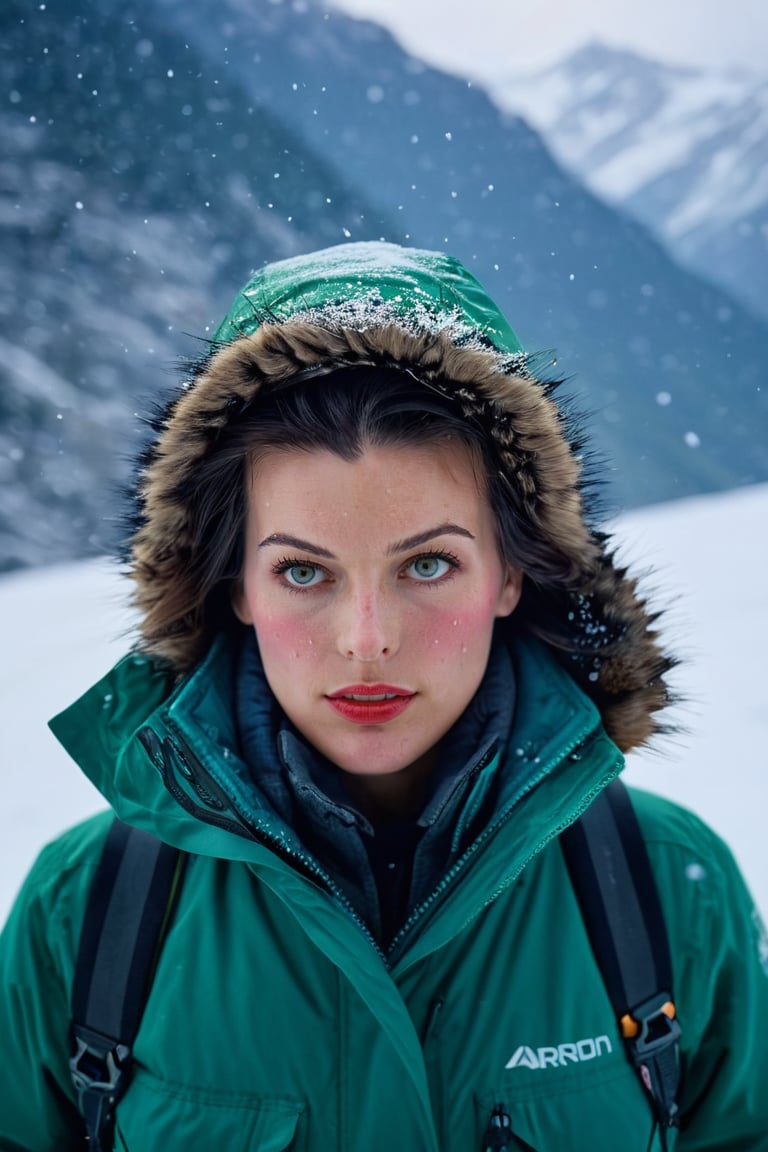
[69, 1025, 131, 1152]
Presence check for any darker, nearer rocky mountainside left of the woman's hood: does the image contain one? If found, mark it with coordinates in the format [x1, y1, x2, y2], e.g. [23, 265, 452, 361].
[0, 0, 396, 570]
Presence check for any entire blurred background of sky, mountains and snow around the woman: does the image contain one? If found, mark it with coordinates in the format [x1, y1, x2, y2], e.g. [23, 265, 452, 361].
[0, 0, 768, 916]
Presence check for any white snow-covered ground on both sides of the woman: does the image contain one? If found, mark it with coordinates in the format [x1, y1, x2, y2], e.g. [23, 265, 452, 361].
[0, 485, 768, 920]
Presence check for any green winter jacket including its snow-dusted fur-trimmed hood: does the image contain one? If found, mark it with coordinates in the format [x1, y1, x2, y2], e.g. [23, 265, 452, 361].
[0, 236, 768, 1152]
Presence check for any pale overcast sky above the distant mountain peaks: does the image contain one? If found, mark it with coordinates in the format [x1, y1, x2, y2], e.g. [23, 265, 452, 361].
[333, 0, 768, 78]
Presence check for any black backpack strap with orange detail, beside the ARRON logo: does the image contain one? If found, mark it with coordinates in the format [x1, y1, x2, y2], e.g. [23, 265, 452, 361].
[561, 780, 680, 1145]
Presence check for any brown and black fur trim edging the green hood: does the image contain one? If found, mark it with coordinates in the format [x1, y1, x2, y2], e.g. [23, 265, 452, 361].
[130, 319, 670, 750]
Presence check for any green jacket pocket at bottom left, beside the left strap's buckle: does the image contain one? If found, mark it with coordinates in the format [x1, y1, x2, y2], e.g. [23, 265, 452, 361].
[115, 1070, 304, 1152]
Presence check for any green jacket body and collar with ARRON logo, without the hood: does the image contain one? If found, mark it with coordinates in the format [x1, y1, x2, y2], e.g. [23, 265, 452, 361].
[0, 642, 768, 1152]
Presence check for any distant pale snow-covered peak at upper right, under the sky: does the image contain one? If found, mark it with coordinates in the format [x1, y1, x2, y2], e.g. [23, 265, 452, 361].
[491, 44, 768, 316]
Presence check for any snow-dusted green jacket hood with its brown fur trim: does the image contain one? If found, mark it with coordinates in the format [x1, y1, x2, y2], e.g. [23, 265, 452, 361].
[127, 243, 671, 751]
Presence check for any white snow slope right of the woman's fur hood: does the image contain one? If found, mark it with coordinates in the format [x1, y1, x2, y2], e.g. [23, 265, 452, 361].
[617, 485, 768, 911]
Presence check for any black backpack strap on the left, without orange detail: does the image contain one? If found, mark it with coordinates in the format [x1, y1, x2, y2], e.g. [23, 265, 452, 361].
[69, 820, 185, 1152]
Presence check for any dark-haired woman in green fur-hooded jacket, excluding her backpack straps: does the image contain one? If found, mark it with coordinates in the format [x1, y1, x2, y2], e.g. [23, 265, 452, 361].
[0, 244, 768, 1152]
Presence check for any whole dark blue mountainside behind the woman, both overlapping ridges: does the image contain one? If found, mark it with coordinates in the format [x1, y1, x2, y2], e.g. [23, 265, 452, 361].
[0, 0, 768, 570]
